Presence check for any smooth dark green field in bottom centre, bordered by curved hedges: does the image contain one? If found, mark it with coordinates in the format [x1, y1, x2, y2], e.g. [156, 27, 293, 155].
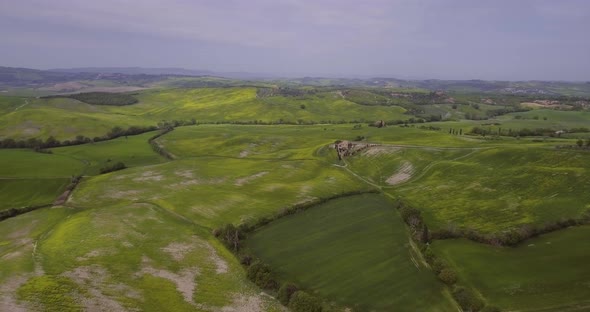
[246, 194, 453, 311]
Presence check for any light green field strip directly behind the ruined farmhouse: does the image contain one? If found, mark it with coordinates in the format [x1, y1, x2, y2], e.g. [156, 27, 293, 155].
[158, 125, 489, 159]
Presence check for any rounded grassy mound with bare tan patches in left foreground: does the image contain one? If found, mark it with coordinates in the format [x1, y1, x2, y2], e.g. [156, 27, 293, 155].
[30, 204, 284, 311]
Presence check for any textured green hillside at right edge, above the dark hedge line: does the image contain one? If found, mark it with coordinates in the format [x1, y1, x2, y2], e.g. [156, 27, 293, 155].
[390, 147, 590, 234]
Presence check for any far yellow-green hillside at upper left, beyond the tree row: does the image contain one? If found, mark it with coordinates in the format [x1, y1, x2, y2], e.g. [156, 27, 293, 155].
[0, 88, 409, 140]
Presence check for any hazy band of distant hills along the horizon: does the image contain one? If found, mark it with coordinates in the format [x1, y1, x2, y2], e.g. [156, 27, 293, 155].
[0, 67, 590, 97]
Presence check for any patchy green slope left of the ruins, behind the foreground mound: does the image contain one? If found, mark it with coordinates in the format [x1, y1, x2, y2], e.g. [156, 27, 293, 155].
[72, 157, 368, 228]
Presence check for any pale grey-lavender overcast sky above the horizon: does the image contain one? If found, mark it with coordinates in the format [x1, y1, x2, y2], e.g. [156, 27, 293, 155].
[0, 0, 590, 81]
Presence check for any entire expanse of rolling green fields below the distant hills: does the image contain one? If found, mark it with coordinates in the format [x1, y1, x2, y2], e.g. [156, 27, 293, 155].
[0, 83, 590, 312]
